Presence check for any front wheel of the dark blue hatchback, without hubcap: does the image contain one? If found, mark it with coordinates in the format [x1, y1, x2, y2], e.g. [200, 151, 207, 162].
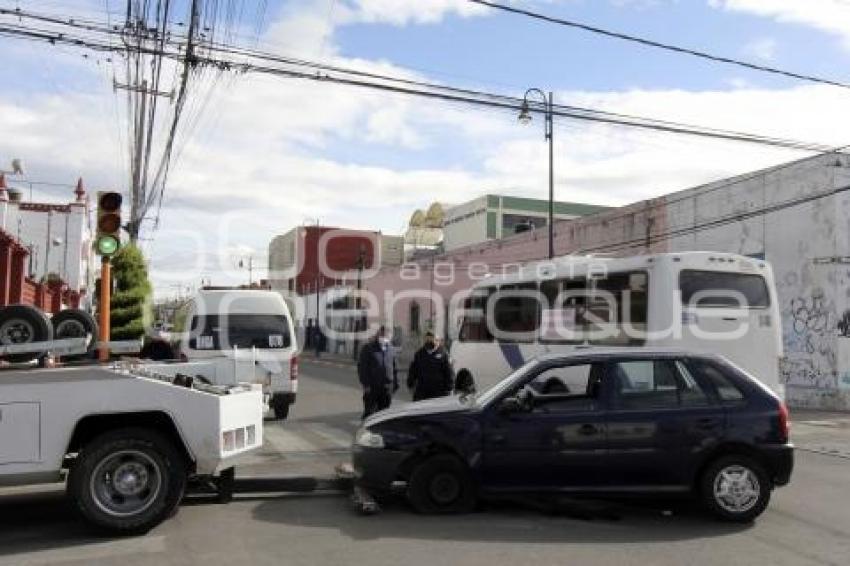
[407, 454, 476, 514]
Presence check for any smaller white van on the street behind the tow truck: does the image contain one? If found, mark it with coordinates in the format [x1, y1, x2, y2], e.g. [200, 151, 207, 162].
[174, 289, 298, 419]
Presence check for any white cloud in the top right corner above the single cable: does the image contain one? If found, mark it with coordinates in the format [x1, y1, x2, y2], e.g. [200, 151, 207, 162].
[709, 0, 850, 47]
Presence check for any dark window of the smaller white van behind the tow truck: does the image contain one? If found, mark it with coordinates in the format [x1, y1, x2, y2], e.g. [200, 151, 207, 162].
[192, 314, 292, 350]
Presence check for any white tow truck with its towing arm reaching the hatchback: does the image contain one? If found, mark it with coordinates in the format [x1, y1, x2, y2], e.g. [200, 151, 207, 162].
[0, 338, 379, 535]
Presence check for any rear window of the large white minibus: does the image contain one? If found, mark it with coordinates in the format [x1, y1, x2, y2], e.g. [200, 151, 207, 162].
[679, 269, 770, 308]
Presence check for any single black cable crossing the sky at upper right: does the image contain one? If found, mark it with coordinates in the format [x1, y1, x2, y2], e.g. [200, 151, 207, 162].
[467, 0, 850, 89]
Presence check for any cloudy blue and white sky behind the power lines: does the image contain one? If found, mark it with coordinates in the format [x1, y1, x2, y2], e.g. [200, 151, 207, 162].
[0, 0, 850, 296]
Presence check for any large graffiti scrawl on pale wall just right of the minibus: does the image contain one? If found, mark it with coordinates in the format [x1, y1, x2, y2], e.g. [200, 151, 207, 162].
[782, 289, 836, 389]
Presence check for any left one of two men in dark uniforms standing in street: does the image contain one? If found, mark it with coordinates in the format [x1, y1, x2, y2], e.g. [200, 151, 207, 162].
[357, 326, 398, 419]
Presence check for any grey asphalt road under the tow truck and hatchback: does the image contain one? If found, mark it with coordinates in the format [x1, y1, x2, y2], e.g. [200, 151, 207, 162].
[0, 363, 850, 566]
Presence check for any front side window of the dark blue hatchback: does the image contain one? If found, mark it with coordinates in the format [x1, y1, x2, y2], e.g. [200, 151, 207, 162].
[525, 364, 602, 412]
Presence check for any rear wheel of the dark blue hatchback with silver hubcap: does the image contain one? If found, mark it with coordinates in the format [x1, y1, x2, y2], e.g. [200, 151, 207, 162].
[700, 455, 771, 523]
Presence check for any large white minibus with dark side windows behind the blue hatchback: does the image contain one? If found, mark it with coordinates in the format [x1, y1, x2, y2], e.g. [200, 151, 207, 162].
[451, 252, 784, 397]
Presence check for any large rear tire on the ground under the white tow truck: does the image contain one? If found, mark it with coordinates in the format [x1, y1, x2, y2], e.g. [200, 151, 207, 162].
[68, 428, 187, 535]
